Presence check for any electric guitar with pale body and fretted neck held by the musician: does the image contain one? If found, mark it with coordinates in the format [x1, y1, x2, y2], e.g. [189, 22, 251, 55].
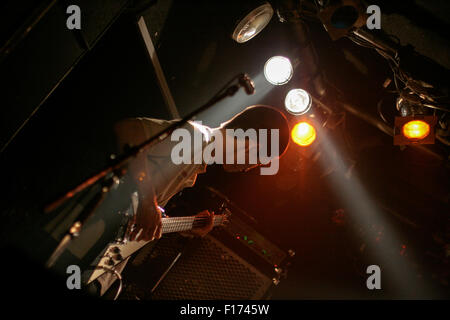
[79, 193, 231, 284]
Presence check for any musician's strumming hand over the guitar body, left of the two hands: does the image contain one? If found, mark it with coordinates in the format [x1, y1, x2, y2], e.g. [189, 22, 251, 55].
[127, 198, 162, 241]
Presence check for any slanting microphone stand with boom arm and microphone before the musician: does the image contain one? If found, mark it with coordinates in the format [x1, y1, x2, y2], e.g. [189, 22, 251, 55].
[44, 74, 254, 268]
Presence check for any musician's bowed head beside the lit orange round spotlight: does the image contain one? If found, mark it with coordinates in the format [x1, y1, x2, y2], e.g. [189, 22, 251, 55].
[221, 105, 289, 172]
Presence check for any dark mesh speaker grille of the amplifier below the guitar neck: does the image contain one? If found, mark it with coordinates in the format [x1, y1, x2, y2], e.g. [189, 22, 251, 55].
[151, 236, 272, 300]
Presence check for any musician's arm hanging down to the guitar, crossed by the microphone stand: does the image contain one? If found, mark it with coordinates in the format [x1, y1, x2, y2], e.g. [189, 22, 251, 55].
[114, 119, 162, 241]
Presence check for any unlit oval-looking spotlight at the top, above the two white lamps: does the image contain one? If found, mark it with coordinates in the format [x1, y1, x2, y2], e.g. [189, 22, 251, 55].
[232, 3, 273, 43]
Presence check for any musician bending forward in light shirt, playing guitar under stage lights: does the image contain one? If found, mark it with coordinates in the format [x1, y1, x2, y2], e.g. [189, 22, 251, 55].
[115, 105, 289, 241]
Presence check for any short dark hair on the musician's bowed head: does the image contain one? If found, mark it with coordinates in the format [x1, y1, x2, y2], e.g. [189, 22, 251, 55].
[223, 105, 290, 157]
